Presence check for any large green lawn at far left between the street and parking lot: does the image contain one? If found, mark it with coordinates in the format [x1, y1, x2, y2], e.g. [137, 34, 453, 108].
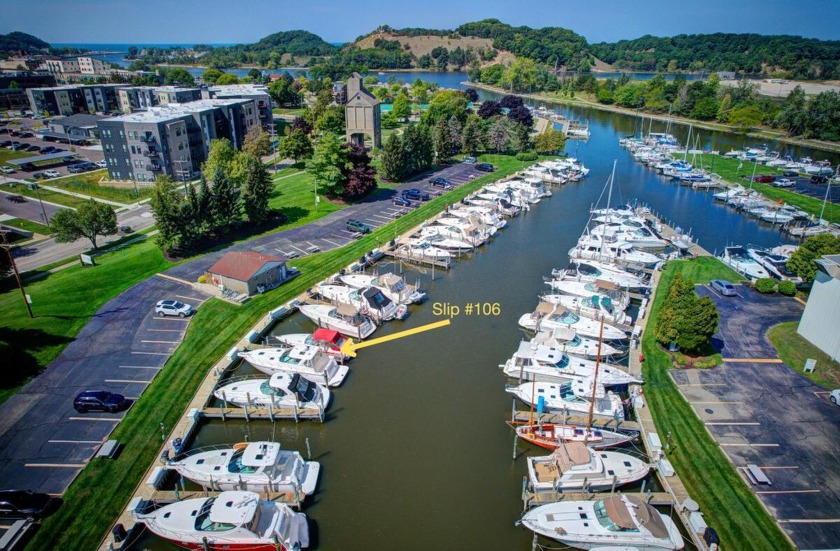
[0, 240, 170, 403]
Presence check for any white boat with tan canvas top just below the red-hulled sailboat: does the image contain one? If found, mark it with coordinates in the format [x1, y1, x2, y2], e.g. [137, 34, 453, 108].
[528, 442, 650, 492]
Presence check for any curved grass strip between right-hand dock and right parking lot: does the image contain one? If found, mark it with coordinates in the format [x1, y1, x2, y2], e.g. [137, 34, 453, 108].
[642, 257, 791, 550]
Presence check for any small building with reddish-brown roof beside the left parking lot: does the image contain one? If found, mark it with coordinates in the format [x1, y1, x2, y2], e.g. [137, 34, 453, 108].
[207, 251, 289, 296]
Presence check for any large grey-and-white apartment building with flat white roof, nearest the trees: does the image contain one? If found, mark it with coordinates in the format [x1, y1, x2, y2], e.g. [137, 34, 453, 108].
[98, 99, 260, 182]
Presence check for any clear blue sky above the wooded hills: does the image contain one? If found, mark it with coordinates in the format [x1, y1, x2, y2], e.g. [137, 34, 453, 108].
[0, 0, 840, 44]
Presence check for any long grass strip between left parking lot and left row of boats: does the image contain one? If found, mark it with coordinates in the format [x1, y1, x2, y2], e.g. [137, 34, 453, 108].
[26, 156, 544, 551]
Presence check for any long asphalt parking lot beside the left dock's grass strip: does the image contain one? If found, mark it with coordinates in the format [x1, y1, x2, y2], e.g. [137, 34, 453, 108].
[0, 164, 481, 494]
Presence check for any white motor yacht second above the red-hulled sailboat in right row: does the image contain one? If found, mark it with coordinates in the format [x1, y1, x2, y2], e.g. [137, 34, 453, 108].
[500, 341, 643, 386]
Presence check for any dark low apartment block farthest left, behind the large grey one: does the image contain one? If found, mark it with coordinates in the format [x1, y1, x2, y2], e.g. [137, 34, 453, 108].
[26, 84, 120, 116]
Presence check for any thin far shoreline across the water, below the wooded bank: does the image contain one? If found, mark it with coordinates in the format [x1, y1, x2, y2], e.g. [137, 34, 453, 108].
[461, 81, 840, 153]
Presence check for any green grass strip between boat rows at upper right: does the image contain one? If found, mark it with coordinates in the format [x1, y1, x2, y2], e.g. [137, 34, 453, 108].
[688, 155, 840, 222]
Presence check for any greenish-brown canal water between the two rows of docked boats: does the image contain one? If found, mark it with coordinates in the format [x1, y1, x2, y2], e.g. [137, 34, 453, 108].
[131, 92, 800, 550]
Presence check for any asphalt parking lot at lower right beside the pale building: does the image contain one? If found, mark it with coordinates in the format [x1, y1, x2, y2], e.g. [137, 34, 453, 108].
[671, 285, 840, 549]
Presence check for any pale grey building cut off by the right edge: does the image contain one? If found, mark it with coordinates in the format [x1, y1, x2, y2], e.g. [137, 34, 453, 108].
[798, 254, 840, 361]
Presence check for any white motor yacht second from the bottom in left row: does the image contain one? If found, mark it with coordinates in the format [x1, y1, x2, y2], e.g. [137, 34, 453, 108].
[166, 442, 321, 495]
